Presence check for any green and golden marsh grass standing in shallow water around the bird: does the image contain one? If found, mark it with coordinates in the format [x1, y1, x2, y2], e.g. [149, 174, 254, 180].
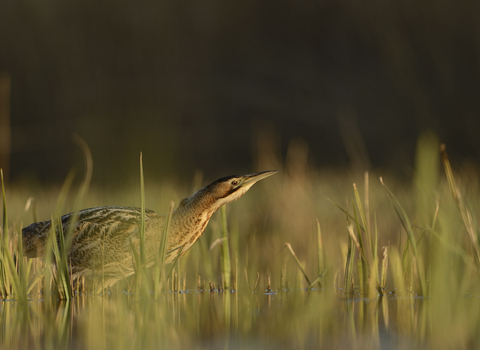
[0, 135, 480, 349]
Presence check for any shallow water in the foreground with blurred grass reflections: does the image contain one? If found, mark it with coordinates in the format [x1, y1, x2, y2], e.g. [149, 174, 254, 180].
[0, 290, 480, 349]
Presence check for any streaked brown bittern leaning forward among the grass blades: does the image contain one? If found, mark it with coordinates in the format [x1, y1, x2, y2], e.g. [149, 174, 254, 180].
[22, 170, 277, 287]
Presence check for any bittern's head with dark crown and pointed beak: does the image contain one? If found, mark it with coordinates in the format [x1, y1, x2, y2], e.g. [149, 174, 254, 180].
[204, 170, 277, 208]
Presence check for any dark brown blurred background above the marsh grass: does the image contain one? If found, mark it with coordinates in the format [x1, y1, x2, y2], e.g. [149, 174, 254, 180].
[0, 0, 480, 183]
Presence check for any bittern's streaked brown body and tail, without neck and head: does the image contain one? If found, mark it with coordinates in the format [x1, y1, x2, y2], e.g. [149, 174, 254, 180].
[22, 207, 164, 273]
